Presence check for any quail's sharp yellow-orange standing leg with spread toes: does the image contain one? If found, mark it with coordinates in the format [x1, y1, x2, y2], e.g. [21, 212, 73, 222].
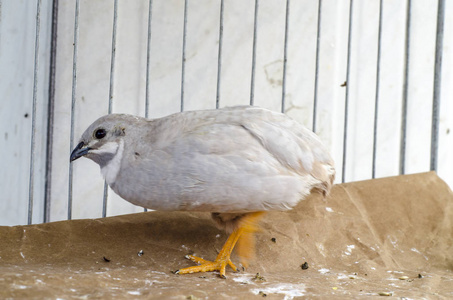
[176, 212, 264, 278]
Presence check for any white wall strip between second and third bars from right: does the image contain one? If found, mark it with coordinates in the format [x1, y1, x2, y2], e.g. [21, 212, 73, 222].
[376, 0, 407, 177]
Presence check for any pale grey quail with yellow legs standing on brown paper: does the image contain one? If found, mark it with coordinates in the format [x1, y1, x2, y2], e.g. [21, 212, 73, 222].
[70, 106, 335, 278]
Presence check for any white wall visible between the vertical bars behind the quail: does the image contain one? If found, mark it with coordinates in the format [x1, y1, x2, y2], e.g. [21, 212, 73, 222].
[0, 0, 453, 225]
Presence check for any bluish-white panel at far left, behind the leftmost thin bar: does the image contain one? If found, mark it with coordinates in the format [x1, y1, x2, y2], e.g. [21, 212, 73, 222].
[0, 1, 51, 225]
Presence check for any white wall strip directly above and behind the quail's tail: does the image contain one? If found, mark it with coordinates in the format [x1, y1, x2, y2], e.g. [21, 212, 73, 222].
[311, 0, 349, 180]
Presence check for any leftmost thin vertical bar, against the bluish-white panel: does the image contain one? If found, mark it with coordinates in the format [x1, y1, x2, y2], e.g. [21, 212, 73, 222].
[28, 0, 41, 225]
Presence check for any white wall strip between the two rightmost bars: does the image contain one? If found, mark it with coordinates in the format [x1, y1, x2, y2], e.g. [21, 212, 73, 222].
[406, 0, 437, 173]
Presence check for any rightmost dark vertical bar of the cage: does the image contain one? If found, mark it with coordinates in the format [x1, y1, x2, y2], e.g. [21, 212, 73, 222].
[430, 0, 445, 171]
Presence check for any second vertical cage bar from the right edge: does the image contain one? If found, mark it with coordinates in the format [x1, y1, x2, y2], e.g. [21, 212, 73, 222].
[399, 0, 412, 175]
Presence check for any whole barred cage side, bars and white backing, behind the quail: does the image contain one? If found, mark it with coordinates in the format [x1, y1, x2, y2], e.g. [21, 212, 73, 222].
[0, 0, 453, 225]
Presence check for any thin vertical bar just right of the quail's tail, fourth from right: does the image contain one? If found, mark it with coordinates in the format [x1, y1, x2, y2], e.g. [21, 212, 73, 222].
[341, 0, 353, 182]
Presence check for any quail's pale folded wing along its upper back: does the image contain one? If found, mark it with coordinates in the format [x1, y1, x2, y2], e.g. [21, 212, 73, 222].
[174, 106, 335, 190]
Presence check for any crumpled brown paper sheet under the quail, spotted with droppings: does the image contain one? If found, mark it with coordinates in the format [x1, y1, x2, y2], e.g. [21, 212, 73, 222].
[0, 172, 453, 299]
